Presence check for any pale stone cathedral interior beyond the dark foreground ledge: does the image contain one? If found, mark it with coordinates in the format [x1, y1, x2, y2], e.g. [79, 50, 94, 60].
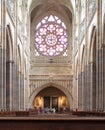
[0, 0, 105, 129]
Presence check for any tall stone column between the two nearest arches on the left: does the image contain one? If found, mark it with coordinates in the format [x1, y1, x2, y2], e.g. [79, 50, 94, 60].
[12, 1, 19, 110]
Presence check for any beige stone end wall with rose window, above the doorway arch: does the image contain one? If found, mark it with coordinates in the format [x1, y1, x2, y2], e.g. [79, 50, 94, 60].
[29, 0, 74, 112]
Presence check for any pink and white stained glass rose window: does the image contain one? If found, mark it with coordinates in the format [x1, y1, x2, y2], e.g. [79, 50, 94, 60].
[35, 15, 68, 56]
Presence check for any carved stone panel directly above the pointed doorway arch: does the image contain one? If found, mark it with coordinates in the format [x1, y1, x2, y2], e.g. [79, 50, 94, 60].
[30, 73, 72, 94]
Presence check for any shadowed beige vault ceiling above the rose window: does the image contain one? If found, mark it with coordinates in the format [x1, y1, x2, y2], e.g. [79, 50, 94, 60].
[29, 0, 73, 23]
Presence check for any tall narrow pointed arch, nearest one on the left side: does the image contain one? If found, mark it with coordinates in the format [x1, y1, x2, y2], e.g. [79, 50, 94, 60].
[6, 25, 13, 110]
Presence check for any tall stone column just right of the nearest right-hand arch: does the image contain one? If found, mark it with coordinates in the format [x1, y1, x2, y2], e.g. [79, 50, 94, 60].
[96, 0, 103, 110]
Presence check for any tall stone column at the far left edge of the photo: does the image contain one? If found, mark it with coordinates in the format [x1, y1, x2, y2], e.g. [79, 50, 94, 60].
[0, 0, 5, 109]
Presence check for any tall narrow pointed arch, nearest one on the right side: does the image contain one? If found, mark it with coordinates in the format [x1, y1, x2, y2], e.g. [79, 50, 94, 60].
[89, 26, 96, 110]
